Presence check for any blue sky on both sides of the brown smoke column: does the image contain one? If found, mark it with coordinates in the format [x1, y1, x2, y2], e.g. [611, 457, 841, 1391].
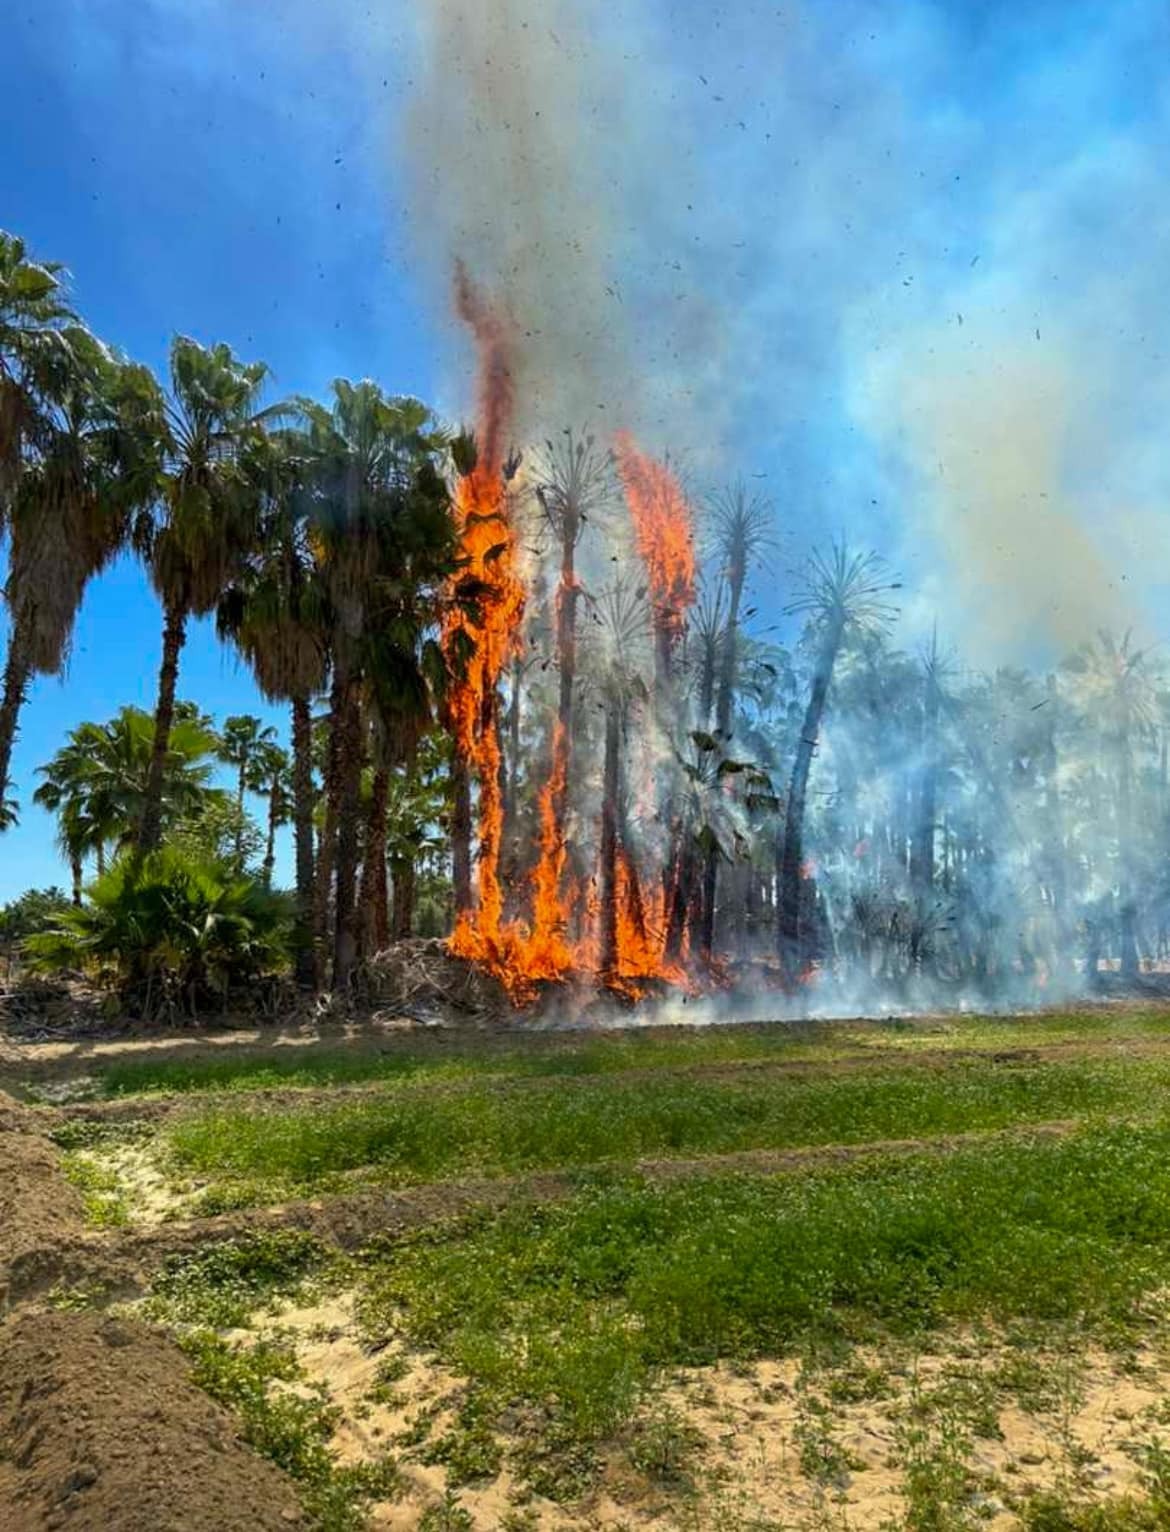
[0, 0, 1170, 899]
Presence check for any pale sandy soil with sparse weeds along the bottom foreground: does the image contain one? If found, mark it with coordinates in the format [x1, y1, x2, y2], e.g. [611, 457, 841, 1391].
[233, 1293, 1170, 1532]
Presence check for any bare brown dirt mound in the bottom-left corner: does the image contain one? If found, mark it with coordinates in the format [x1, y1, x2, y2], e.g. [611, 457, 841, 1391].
[0, 1313, 306, 1532]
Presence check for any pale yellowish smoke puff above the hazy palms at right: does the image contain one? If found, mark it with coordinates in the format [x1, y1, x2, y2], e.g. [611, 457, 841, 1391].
[873, 332, 1136, 663]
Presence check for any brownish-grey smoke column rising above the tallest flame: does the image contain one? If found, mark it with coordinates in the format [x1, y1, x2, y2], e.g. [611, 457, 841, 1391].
[406, 0, 634, 438]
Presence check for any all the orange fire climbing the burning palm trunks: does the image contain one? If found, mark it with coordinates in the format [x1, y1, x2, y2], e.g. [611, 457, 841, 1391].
[443, 283, 695, 1005]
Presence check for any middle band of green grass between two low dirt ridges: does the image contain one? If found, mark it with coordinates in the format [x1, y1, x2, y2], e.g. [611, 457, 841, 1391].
[164, 1059, 1170, 1190]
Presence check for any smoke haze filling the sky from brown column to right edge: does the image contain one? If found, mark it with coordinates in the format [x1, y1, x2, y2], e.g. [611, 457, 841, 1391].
[406, 0, 1170, 663]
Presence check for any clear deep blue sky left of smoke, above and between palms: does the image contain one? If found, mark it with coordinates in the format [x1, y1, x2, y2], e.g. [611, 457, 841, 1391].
[0, 0, 433, 899]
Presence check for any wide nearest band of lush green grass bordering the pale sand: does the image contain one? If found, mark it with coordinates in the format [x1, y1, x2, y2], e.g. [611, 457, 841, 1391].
[349, 1123, 1170, 1489]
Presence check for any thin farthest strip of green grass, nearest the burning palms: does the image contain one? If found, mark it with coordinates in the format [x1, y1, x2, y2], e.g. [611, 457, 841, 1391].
[77, 1011, 1170, 1097]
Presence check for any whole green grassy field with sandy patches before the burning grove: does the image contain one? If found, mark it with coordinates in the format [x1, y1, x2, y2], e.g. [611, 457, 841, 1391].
[45, 1013, 1170, 1532]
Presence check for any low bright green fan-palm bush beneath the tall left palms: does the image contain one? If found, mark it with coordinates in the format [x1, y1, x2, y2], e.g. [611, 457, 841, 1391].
[23, 847, 293, 1019]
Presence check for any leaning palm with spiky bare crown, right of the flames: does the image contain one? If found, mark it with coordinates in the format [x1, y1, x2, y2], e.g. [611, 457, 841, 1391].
[778, 542, 900, 982]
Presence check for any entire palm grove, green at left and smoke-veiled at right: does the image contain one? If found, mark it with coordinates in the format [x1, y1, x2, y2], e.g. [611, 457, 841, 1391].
[0, 234, 1170, 1010]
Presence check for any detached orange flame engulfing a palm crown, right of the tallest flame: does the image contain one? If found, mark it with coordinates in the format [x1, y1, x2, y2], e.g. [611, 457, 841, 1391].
[614, 430, 695, 640]
